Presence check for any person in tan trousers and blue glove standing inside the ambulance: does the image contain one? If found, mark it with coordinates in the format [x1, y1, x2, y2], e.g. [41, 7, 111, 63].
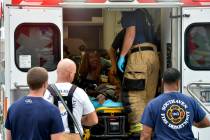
[117, 9, 159, 134]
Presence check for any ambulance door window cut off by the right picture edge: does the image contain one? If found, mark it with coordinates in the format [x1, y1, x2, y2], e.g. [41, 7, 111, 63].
[185, 23, 210, 70]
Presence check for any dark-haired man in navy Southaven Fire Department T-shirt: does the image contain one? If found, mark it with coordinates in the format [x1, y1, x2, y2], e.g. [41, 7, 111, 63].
[141, 68, 210, 140]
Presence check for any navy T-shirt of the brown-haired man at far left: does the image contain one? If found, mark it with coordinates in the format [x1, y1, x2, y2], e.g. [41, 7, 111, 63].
[5, 96, 64, 140]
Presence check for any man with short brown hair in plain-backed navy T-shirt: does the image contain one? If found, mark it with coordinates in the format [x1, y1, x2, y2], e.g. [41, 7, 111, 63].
[5, 67, 64, 140]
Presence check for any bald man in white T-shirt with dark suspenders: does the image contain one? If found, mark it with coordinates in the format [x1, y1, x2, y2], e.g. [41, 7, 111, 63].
[44, 58, 98, 140]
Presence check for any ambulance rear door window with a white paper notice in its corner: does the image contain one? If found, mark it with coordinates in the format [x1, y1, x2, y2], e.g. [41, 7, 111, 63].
[14, 23, 61, 72]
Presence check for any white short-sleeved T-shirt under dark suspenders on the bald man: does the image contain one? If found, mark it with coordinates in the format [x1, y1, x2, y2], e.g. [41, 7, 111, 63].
[44, 83, 95, 133]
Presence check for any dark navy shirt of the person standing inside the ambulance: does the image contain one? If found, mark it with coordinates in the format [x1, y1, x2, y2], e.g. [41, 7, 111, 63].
[112, 9, 154, 51]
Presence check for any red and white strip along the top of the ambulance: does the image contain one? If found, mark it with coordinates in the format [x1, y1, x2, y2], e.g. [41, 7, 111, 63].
[11, 0, 210, 8]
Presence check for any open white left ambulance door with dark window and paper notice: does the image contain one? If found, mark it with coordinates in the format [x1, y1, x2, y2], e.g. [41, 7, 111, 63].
[5, 6, 63, 101]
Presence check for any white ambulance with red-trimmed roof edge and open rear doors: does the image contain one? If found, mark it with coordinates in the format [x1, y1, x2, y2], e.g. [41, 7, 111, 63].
[0, 0, 210, 140]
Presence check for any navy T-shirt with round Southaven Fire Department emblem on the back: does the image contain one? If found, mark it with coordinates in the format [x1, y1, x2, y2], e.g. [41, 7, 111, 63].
[141, 92, 206, 140]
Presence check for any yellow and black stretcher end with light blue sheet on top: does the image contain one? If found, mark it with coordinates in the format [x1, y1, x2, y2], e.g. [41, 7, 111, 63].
[84, 100, 128, 140]
